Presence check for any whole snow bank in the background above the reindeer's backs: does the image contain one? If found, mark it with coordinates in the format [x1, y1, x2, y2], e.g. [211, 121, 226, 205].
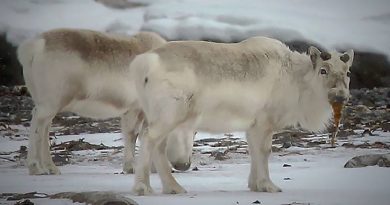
[0, 0, 390, 55]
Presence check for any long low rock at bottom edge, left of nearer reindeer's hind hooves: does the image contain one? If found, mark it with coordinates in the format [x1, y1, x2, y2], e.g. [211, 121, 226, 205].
[50, 191, 138, 205]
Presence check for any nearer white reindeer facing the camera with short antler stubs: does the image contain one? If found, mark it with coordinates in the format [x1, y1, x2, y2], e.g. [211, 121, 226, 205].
[130, 37, 354, 195]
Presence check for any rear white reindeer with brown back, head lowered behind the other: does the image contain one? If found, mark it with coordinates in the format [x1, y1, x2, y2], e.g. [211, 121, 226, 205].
[18, 29, 193, 175]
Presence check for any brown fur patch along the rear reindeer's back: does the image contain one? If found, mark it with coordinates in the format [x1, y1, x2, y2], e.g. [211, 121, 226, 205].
[42, 29, 144, 66]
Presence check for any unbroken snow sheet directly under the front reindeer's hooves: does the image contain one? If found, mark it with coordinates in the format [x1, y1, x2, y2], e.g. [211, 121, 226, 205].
[0, 149, 390, 205]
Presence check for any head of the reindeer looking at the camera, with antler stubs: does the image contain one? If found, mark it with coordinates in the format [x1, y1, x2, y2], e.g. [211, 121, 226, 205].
[308, 46, 354, 103]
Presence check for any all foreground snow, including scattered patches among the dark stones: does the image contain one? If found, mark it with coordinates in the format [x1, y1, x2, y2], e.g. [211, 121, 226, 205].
[0, 132, 390, 205]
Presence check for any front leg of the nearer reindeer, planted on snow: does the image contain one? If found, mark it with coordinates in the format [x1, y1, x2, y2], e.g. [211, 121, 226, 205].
[246, 120, 282, 192]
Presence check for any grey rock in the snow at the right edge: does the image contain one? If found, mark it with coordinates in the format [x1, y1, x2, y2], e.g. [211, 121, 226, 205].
[344, 153, 390, 168]
